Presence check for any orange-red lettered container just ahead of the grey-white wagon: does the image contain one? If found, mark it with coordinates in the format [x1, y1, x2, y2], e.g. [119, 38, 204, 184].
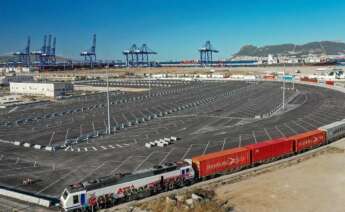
[288, 130, 326, 152]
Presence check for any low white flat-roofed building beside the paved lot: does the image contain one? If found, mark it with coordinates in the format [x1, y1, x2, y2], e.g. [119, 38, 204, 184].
[10, 82, 73, 97]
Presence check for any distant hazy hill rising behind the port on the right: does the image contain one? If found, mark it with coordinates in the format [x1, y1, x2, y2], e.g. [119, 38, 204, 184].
[234, 41, 345, 57]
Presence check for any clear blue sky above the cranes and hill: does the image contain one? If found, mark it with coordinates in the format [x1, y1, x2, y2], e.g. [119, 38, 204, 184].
[0, 0, 345, 60]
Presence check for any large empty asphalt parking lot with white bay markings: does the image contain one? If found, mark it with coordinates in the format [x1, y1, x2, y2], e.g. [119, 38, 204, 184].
[0, 81, 345, 199]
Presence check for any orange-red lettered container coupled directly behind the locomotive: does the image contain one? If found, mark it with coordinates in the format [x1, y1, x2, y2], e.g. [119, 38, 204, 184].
[192, 147, 250, 177]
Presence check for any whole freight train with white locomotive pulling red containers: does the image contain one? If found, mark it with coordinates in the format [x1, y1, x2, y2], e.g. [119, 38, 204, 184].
[60, 119, 345, 211]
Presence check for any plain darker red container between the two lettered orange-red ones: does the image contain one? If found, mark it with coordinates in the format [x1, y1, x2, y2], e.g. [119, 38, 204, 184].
[245, 138, 294, 164]
